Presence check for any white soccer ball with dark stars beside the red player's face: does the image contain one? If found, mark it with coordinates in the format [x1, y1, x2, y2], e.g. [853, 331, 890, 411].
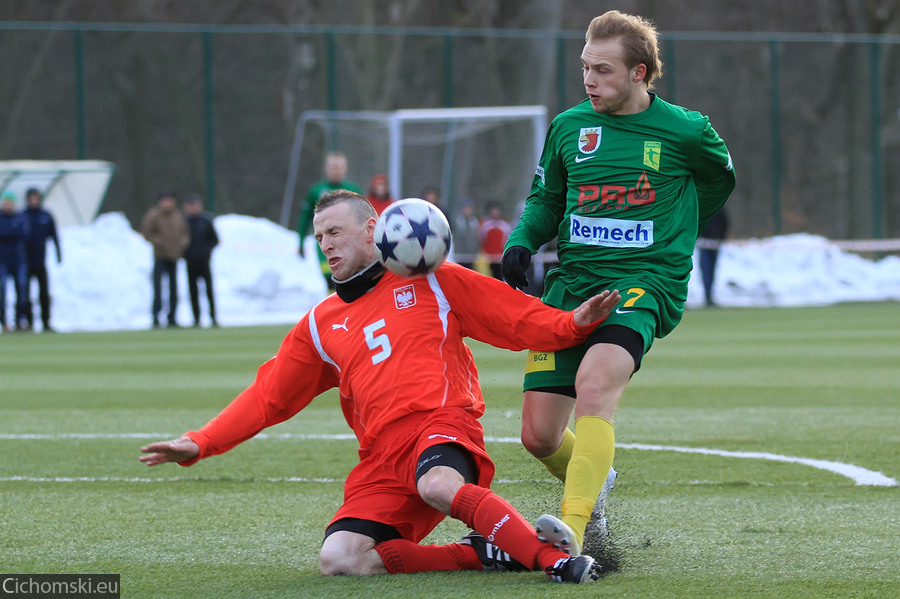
[375, 198, 450, 277]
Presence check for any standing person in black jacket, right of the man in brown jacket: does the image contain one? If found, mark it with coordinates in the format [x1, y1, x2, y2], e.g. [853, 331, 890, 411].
[184, 194, 219, 327]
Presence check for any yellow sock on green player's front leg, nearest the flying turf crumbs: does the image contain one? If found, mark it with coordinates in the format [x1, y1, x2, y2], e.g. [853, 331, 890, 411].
[562, 416, 616, 546]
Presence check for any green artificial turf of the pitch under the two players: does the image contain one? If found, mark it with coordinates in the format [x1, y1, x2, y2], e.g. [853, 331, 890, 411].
[0, 303, 900, 599]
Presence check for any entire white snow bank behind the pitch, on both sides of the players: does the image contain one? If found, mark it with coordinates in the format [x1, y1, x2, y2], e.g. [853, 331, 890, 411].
[1, 213, 900, 331]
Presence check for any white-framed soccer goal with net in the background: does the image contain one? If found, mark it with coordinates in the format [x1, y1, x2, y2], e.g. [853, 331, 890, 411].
[281, 106, 547, 228]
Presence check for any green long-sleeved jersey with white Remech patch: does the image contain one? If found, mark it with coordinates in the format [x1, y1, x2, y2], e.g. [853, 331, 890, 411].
[506, 94, 735, 337]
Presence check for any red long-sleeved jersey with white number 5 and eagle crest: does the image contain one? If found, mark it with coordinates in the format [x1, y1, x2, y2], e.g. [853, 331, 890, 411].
[185, 263, 597, 465]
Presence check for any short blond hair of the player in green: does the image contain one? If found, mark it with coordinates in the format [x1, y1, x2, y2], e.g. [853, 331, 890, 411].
[584, 10, 662, 89]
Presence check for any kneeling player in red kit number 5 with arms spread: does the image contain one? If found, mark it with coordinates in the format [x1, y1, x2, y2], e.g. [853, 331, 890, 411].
[140, 190, 619, 583]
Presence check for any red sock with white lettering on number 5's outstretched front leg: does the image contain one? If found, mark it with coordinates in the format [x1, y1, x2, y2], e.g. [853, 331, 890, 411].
[450, 484, 568, 570]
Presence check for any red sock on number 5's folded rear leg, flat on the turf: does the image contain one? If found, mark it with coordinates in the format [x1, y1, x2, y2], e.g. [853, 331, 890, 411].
[375, 539, 483, 574]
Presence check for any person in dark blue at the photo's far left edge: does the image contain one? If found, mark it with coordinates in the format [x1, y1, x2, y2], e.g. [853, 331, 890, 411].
[0, 192, 28, 333]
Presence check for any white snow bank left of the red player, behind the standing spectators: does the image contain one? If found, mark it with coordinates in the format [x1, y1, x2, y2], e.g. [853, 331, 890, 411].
[38, 213, 326, 331]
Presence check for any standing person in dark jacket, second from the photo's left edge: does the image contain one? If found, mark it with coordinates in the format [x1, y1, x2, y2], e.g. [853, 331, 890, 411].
[22, 187, 62, 333]
